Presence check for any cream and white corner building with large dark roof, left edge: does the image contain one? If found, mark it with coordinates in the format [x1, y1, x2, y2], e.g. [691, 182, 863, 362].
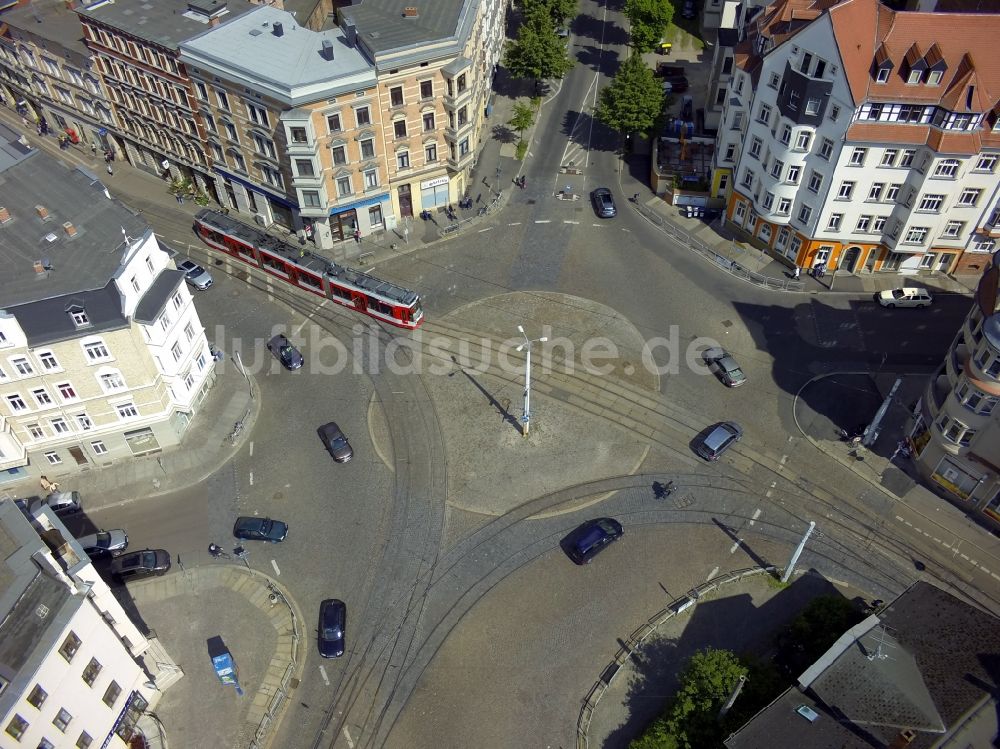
[0, 126, 214, 482]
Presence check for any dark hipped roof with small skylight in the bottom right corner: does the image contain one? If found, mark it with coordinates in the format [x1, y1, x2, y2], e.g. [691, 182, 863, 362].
[726, 582, 1000, 749]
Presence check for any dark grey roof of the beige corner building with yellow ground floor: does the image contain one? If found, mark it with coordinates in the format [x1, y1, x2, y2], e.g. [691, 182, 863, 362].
[340, 0, 472, 56]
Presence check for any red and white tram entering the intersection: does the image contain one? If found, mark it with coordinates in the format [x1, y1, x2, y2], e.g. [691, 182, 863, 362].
[194, 208, 424, 330]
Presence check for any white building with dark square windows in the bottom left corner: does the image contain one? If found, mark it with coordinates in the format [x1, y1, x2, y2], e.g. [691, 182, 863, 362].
[0, 499, 180, 749]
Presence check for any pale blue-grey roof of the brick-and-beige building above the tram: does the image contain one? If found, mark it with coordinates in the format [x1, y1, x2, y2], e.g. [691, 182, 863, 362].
[181, 6, 375, 106]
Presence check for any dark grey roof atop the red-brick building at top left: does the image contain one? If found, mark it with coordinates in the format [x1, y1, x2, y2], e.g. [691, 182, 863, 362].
[77, 0, 257, 50]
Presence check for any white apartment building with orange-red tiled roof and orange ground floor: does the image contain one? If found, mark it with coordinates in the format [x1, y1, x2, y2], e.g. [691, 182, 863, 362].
[713, 0, 1000, 273]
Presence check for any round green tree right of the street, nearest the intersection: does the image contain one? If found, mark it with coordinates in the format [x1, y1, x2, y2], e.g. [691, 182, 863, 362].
[594, 54, 663, 135]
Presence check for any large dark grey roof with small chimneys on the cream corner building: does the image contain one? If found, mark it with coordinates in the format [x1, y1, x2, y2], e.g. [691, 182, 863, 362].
[0, 124, 149, 310]
